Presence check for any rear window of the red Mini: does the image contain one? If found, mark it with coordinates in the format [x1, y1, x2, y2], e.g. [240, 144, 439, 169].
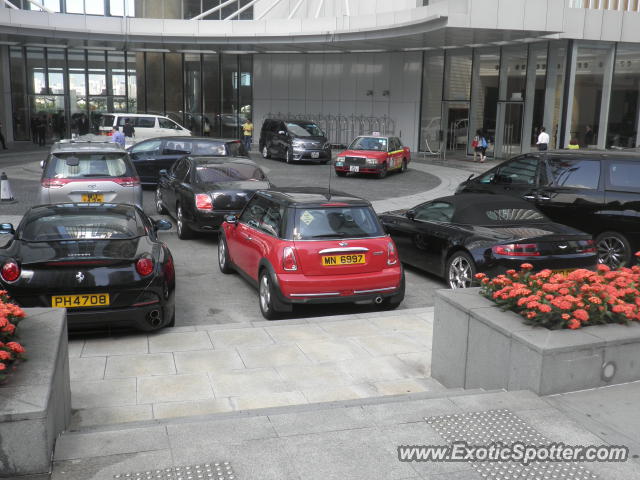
[293, 207, 384, 240]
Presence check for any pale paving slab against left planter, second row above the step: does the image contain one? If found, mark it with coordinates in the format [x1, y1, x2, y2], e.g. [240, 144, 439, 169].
[71, 378, 136, 408]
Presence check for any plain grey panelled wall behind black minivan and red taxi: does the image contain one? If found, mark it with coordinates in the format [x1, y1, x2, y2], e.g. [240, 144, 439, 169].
[253, 52, 422, 150]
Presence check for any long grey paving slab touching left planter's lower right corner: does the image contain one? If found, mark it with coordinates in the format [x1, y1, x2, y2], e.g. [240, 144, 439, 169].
[54, 427, 169, 460]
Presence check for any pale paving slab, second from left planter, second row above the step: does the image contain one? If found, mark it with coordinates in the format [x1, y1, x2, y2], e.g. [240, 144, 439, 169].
[138, 374, 213, 403]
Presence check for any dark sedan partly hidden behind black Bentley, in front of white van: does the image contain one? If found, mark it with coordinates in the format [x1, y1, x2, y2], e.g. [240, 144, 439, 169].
[129, 137, 249, 186]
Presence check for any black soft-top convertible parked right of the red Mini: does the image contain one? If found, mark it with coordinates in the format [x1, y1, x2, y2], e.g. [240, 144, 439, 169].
[380, 194, 597, 288]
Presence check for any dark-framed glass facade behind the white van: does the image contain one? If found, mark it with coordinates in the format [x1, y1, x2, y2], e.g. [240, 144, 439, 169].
[4, 47, 253, 141]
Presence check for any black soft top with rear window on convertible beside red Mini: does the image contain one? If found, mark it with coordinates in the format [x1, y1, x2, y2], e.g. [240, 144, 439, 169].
[453, 203, 548, 225]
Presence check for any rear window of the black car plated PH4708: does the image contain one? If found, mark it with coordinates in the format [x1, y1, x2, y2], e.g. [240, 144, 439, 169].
[20, 210, 145, 242]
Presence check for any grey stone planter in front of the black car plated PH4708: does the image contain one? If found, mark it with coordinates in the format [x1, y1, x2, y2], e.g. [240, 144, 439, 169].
[0, 308, 71, 478]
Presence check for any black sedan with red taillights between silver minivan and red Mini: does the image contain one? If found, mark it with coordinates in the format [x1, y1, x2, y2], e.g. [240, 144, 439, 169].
[156, 157, 271, 240]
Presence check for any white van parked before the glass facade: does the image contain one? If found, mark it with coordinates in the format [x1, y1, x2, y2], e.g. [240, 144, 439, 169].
[98, 113, 191, 143]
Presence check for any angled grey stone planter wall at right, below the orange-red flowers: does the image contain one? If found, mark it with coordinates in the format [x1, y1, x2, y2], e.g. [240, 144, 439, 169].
[431, 288, 640, 395]
